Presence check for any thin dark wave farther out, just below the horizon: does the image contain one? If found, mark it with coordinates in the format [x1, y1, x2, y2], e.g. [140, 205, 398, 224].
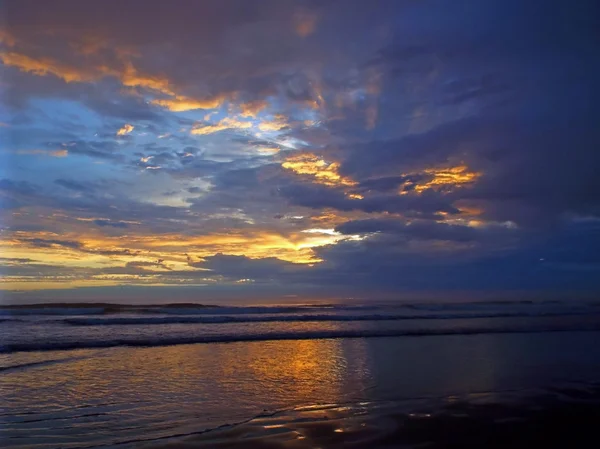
[56, 312, 589, 326]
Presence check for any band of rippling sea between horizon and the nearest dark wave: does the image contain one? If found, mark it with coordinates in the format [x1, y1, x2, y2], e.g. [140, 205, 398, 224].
[0, 301, 600, 353]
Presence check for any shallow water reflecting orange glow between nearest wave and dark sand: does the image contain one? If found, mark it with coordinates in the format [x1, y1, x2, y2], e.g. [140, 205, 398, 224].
[1, 332, 600, 447]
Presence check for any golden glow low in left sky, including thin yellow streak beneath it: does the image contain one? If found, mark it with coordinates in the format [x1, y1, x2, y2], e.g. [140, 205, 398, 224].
[0, 218, 368, 290]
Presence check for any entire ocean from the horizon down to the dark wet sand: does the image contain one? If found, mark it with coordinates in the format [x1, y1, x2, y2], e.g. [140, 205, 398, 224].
[0, 301, 600, 448]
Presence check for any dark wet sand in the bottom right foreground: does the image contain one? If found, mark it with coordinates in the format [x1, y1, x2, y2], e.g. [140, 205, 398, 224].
[146, 384, 600, 449]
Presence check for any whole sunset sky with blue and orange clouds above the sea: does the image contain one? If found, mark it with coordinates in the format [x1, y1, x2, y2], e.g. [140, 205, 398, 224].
[0, 0, 600, 302]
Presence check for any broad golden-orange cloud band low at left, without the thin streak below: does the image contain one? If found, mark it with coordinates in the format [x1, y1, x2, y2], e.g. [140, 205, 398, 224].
[0, 226, 332, 270]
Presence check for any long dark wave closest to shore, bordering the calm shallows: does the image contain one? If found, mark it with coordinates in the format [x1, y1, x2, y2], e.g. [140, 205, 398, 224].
[0, 326, 600, 354]
